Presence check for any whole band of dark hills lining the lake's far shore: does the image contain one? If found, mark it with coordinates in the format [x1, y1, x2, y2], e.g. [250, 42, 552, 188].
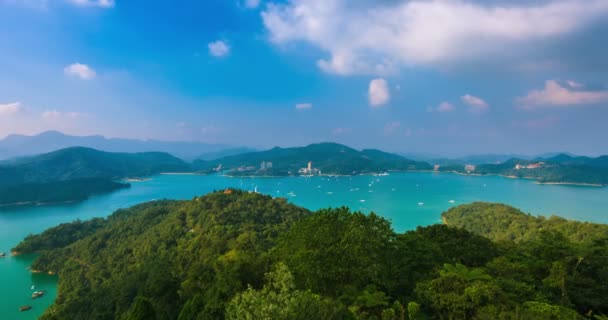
[0, 139, 608, 205]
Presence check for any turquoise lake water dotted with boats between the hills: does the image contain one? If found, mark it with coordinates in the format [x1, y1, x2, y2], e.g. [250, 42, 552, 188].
[0, 173, 608, 320]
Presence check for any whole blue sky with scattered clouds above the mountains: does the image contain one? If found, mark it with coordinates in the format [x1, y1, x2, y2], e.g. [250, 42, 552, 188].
[0, 0, 608, 156]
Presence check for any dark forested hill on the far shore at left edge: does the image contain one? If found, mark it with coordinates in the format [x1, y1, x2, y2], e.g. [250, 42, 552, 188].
[0, 147, 190, 204]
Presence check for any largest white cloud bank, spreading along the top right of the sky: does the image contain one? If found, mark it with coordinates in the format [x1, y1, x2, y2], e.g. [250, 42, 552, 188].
[262, 0, 608, 75]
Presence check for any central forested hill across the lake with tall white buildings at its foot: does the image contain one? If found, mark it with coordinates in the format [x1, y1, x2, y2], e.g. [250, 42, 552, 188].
[194, 143, 431, 175]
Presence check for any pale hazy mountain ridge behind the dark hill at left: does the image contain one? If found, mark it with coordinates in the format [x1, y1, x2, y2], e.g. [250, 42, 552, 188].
[0, 131, 240, 161]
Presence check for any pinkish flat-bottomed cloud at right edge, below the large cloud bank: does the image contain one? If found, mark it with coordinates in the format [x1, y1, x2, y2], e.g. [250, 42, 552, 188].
[517, 80, 608, 109]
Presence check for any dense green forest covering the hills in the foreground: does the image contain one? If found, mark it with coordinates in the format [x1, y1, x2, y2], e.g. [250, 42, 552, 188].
[15, 190, 608, 320]
